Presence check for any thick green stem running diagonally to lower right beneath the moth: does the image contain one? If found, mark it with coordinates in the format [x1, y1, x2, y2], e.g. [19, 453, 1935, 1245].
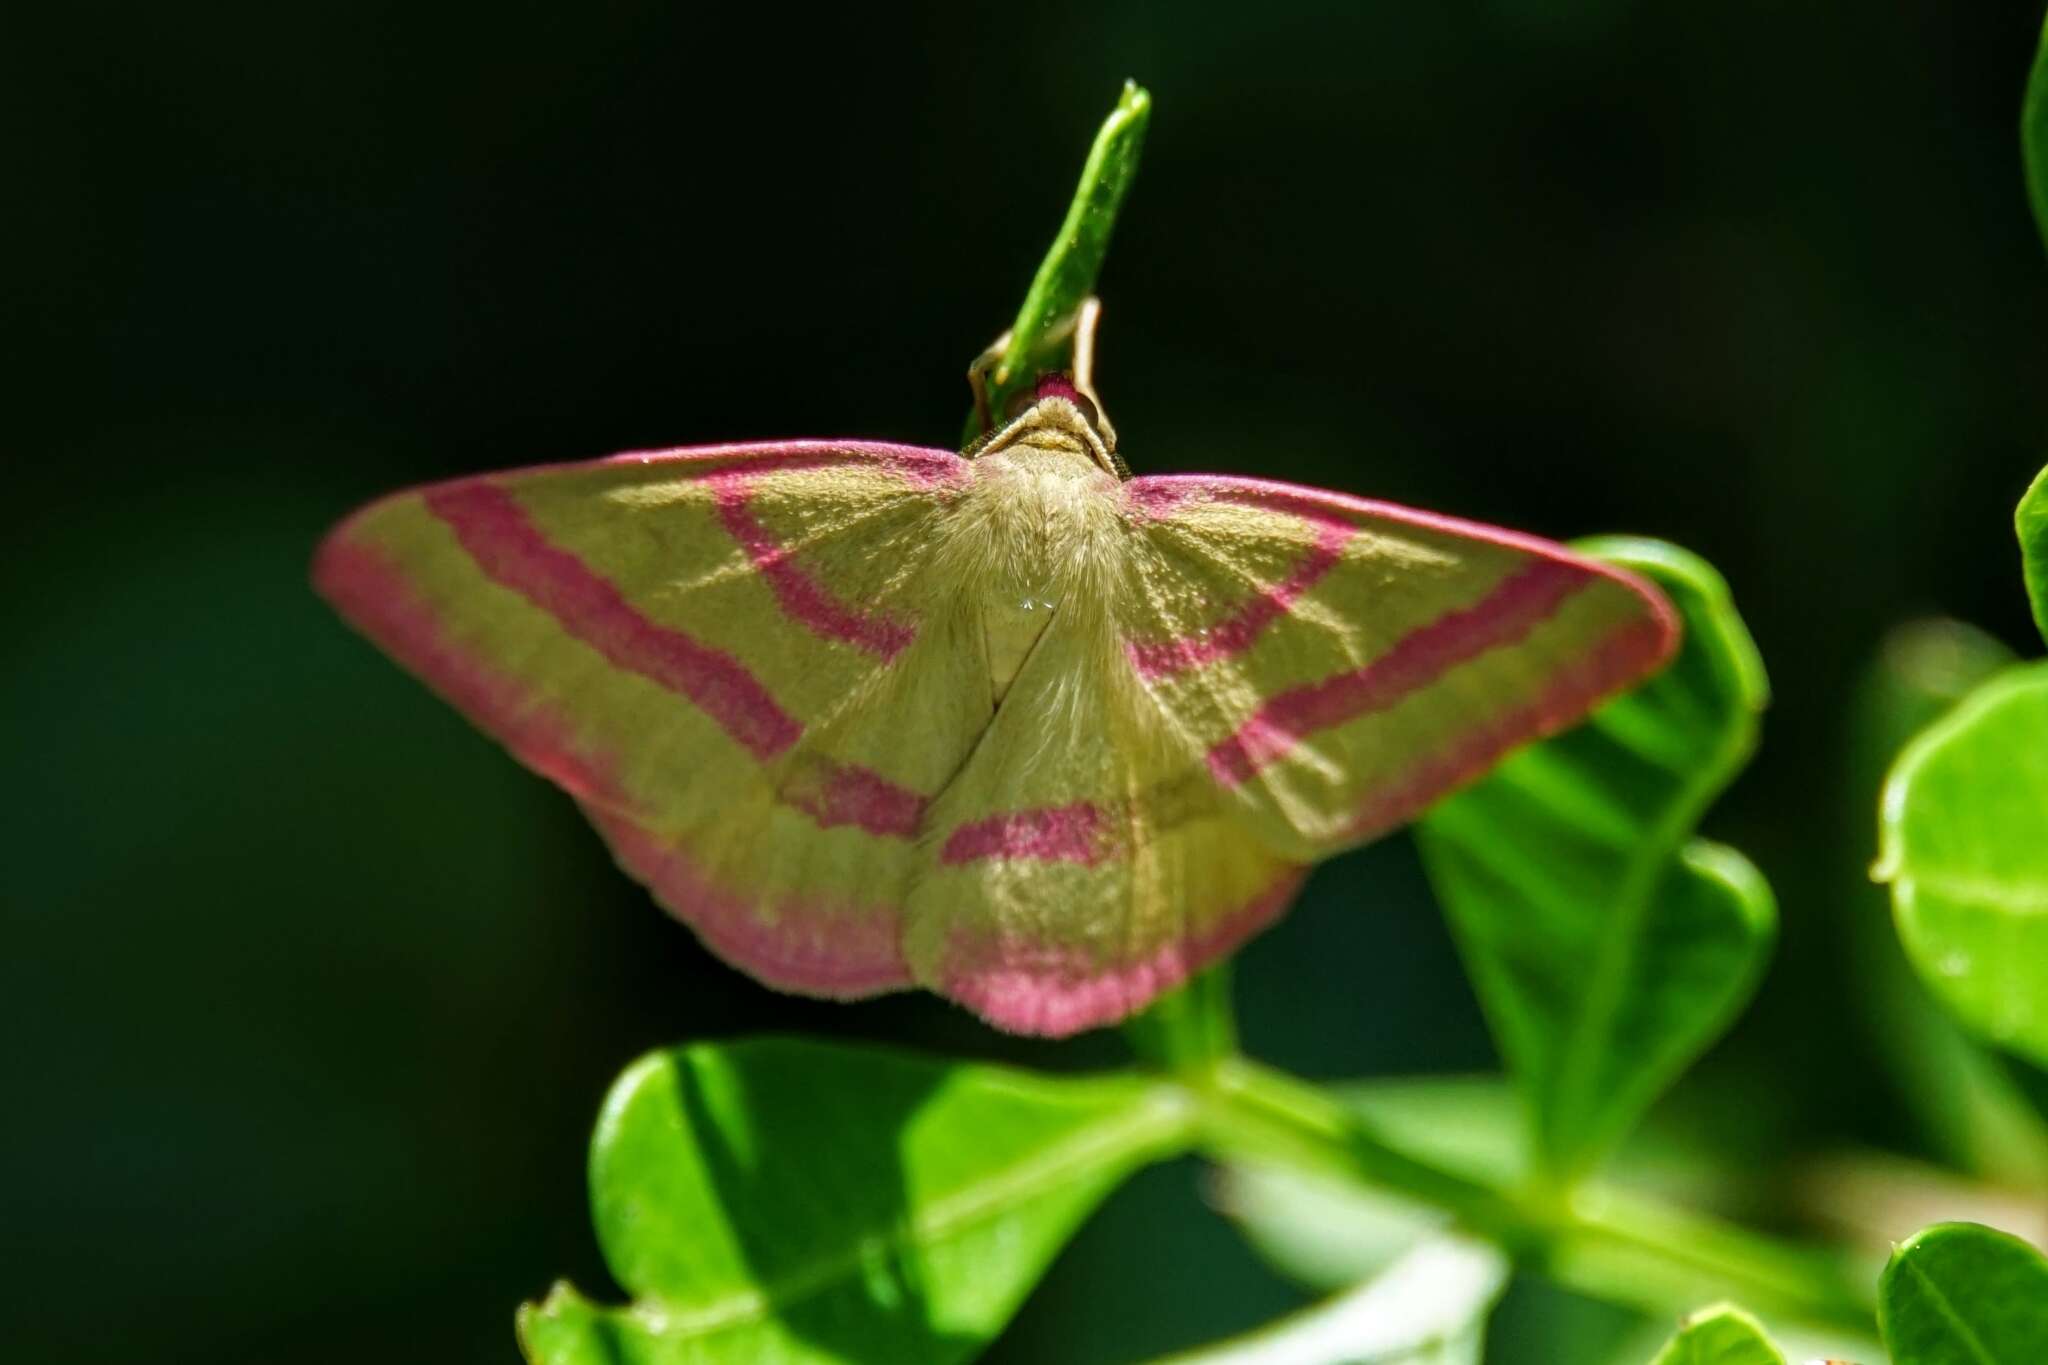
[1184, 1058, 1874, 1332]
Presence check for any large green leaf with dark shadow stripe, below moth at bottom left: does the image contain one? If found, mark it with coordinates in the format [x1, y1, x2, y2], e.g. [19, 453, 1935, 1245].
[520, 1040, 1190, 1365]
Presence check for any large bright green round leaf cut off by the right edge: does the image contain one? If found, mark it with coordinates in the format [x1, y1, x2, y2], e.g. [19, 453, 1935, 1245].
[1874, 663, 2048, 1062]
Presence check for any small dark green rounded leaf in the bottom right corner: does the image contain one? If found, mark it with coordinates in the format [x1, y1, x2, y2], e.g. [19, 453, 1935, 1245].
[1878, 1224, 2048, 1365]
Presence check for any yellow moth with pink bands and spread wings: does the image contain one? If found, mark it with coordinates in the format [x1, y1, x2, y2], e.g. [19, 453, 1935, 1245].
[313, 303, 1677, 1036]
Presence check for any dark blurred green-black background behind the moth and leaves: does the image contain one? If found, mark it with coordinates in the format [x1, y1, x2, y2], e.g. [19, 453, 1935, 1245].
[16, 0, 2048, 1363]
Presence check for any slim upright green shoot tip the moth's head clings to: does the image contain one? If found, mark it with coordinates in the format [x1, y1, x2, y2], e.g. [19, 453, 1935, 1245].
[967, 80, 1151, 440]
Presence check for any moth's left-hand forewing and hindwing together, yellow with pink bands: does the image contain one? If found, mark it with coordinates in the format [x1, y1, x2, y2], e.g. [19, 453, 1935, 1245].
[315, 442, 991, 997]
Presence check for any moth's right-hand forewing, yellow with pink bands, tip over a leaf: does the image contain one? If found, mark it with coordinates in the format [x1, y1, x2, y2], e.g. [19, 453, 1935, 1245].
[1124, 475, 1677, 862]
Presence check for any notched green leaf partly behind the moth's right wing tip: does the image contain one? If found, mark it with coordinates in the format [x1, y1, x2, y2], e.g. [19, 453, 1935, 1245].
[1417, 538, 1776, 1179]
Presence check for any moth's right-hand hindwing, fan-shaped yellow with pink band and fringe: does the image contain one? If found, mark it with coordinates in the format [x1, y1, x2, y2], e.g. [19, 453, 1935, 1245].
[905, 602, 1305, 1036]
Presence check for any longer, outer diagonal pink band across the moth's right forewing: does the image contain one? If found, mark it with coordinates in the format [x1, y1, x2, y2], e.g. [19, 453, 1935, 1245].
[1208, 559, 1599, 786]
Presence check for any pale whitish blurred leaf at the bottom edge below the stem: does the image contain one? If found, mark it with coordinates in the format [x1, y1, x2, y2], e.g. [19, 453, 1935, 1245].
[1157, 1238, 1507, 1365]
